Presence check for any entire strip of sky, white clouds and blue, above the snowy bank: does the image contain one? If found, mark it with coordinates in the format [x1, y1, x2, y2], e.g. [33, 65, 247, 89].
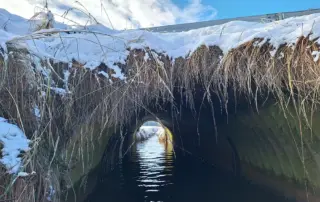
[0, 0, 320, 30]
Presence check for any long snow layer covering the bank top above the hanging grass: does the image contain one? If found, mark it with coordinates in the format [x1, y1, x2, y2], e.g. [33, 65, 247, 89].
[0, 9, 320, 81]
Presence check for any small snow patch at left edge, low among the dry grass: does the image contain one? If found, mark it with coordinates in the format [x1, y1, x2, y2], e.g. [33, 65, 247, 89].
[0, 117, 30, 174]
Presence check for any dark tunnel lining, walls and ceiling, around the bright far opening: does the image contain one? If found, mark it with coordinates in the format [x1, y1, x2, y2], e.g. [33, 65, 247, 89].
[80, 85, 319, 201]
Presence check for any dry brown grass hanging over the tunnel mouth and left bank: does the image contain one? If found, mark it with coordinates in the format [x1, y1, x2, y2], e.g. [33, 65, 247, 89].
[0, 29, 320, 201]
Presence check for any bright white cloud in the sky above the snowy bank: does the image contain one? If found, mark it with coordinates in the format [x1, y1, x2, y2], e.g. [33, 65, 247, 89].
[0, 0, 216, 29]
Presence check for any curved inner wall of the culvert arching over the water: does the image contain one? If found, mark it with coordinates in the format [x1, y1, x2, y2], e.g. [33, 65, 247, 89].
[67, 97, 320, 201]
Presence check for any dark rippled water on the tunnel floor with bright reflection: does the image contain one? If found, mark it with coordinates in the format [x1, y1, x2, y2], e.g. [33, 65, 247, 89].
[88, 136, 292, 202]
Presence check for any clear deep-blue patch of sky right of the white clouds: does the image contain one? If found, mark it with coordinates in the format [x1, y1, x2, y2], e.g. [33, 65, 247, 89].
[172, 0, 320, 19]
